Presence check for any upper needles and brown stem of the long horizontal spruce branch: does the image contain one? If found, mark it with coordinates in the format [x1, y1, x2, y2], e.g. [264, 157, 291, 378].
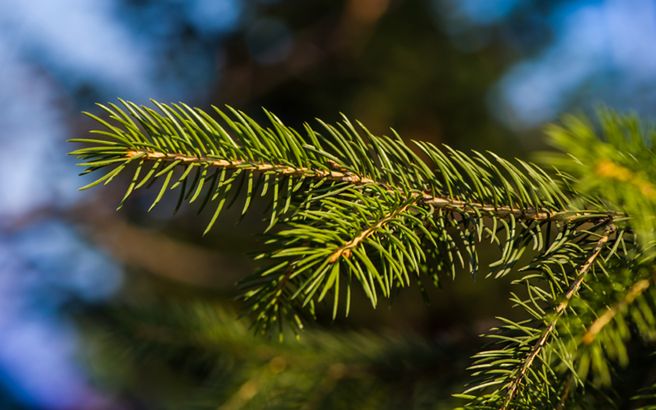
[71, 100, 608, 226]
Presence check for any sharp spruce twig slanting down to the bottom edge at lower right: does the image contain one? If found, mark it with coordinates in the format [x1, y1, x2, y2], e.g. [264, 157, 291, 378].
[457, 219, 630, 409]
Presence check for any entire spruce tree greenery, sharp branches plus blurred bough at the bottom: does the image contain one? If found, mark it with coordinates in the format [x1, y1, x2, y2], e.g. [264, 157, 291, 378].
[71, 101, 656, 409]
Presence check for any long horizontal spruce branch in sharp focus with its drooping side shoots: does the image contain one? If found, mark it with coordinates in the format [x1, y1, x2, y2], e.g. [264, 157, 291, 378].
[72, 101, 612, 332]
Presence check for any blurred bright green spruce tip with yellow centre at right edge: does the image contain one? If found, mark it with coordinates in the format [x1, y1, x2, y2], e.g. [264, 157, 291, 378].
[545, 110, 656, 250]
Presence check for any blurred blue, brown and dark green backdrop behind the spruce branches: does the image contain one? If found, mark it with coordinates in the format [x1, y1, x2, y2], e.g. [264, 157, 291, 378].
[0, 0, 656, 409]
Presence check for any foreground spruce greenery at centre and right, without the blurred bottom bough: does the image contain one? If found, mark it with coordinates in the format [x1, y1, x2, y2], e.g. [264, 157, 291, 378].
[73, 102, 656, 409]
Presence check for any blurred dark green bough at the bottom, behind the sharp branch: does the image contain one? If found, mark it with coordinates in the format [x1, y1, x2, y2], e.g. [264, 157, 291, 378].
[82, 301, 460, 410]
